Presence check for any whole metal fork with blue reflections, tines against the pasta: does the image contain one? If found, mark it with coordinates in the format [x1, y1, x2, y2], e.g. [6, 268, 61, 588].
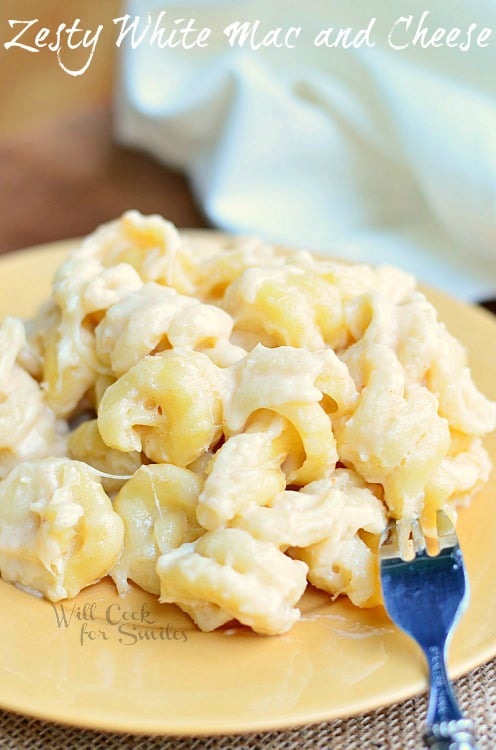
[380, 511, 477, 750]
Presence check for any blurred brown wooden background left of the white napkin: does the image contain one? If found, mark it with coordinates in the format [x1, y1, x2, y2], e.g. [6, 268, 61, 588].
[0, 0, 206, 252]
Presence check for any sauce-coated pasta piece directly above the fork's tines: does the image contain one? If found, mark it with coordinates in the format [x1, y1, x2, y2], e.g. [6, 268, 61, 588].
[337, 345, 450, 523]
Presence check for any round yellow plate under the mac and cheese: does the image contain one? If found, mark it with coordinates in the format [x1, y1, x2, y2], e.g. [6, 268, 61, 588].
[0, 238, 496, 735]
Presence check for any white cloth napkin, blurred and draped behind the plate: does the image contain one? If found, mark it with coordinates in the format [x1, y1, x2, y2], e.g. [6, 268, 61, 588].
[115, 0, 496, 300]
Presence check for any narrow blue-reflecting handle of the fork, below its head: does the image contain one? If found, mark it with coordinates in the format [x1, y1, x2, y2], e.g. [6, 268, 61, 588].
[424, 646, 477, 750]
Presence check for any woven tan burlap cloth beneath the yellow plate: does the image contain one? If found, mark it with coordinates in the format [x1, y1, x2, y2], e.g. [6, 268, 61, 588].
[0, 659, 496, 750]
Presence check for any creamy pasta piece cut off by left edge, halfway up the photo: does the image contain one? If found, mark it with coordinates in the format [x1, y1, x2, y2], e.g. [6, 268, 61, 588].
[0, 318, 66, 477]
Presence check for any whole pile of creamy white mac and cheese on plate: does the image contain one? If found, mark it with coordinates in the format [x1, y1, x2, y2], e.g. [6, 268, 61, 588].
[0, 211, 496, 634]
